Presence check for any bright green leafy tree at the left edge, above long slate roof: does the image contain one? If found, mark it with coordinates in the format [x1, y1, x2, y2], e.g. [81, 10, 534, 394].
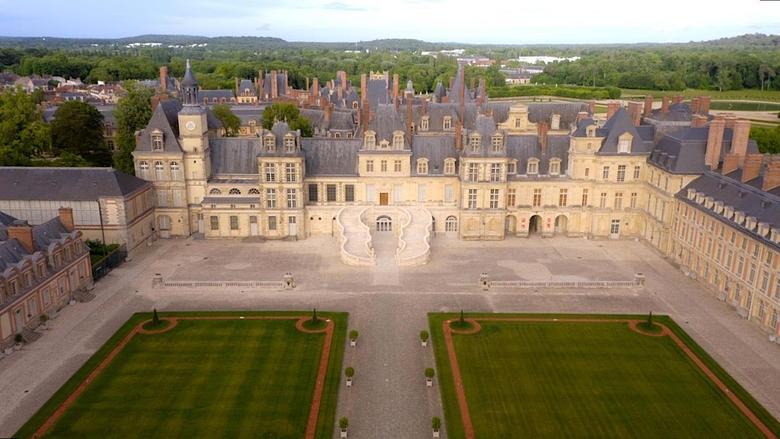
[0, 89, 50, 166]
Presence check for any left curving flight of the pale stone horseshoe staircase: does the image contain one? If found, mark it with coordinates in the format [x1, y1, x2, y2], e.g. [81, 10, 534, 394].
[336, 206, 376, 266]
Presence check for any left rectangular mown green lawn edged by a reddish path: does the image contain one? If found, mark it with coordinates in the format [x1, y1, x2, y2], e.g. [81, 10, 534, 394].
[17, 313, 346, 438]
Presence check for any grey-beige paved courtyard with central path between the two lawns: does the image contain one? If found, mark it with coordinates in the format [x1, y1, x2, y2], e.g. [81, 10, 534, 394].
[0, 237, 780, 438]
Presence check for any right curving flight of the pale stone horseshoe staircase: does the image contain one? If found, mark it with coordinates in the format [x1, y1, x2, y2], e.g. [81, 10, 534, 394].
[396, 207, 433, 266]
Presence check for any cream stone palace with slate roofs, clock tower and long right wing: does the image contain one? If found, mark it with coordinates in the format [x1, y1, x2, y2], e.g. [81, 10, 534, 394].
[134, 63, 780, 334]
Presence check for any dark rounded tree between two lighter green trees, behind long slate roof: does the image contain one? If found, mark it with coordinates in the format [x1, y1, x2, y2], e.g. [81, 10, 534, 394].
[51, 101, 111, 166]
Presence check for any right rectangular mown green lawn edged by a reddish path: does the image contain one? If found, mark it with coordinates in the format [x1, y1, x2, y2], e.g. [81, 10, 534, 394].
[429, 314, 780, 438]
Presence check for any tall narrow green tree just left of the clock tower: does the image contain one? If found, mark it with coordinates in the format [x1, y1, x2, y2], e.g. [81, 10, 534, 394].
[114, 82, 154, 175]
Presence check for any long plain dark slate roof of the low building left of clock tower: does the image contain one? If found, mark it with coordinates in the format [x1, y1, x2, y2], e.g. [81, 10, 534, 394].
[0, 167, 152, 201]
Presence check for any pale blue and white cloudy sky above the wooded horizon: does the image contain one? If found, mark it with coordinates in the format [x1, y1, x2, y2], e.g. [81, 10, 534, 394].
[0, 0, 780, 44]
